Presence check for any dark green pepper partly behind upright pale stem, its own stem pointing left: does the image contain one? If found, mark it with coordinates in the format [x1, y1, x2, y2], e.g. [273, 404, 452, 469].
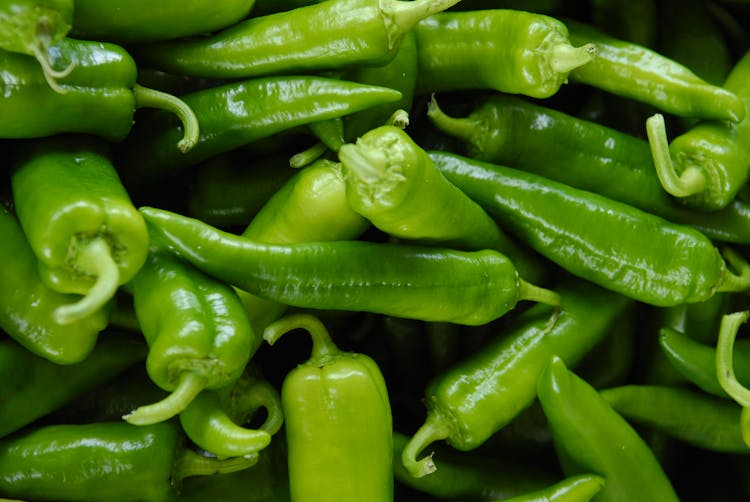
[427, 96, 750, 243]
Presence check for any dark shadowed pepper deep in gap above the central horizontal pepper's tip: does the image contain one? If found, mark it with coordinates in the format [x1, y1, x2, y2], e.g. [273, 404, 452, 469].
[187, 155, 295, 227]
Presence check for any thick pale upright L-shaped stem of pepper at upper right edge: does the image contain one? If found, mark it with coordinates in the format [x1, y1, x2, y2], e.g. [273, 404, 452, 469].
[646, 113, 707, 197]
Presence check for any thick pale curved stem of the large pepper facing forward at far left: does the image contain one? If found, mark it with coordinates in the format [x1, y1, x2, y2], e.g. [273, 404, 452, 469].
[52, 237, 120, 324]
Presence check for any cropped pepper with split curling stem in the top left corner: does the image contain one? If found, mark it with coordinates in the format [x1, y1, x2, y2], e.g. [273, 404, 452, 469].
[0, 0, 73, 92]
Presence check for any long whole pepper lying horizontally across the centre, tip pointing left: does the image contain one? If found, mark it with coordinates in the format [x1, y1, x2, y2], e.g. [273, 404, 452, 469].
[140, 207, 559, 325]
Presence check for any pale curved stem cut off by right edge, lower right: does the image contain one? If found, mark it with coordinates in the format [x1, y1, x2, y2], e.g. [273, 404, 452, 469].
[716, 310, 750, 446]
